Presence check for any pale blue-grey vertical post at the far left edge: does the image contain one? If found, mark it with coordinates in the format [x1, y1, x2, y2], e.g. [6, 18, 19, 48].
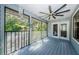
[0, 4, 5, 54]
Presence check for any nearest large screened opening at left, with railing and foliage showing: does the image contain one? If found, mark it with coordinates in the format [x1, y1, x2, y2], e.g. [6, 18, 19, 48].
[4, 8, 29, 54]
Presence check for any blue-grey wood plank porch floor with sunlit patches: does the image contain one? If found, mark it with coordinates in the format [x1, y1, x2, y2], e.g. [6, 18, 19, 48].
[13, 38, 77, 55]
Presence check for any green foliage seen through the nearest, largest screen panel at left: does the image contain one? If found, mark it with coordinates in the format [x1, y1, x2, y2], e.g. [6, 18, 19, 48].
[5, 13, 28, 31]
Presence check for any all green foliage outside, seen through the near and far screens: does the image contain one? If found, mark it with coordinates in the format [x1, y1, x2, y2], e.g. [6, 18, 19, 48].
[5, 13, 47, 31]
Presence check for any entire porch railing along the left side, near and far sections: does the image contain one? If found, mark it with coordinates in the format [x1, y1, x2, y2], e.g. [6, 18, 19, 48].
[5, 31, 47, 54]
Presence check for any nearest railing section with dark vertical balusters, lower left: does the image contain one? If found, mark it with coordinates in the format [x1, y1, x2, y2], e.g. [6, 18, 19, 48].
[5, 31, 29, 54]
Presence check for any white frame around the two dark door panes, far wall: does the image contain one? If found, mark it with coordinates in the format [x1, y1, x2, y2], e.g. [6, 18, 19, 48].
[52, 21, 69, 40]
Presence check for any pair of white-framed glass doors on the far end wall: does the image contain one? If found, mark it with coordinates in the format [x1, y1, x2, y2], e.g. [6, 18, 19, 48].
[52, 21, 69, 40]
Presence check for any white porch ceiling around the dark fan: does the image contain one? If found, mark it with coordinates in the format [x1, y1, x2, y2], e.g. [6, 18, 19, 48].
[20, 4, 77, 19]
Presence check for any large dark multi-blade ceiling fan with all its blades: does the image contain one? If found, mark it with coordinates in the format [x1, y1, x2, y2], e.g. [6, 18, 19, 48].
[40, 4, 70, 19]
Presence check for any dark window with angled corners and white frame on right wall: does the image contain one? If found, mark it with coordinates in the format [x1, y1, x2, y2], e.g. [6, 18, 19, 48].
[73, 11, 79, 41]
